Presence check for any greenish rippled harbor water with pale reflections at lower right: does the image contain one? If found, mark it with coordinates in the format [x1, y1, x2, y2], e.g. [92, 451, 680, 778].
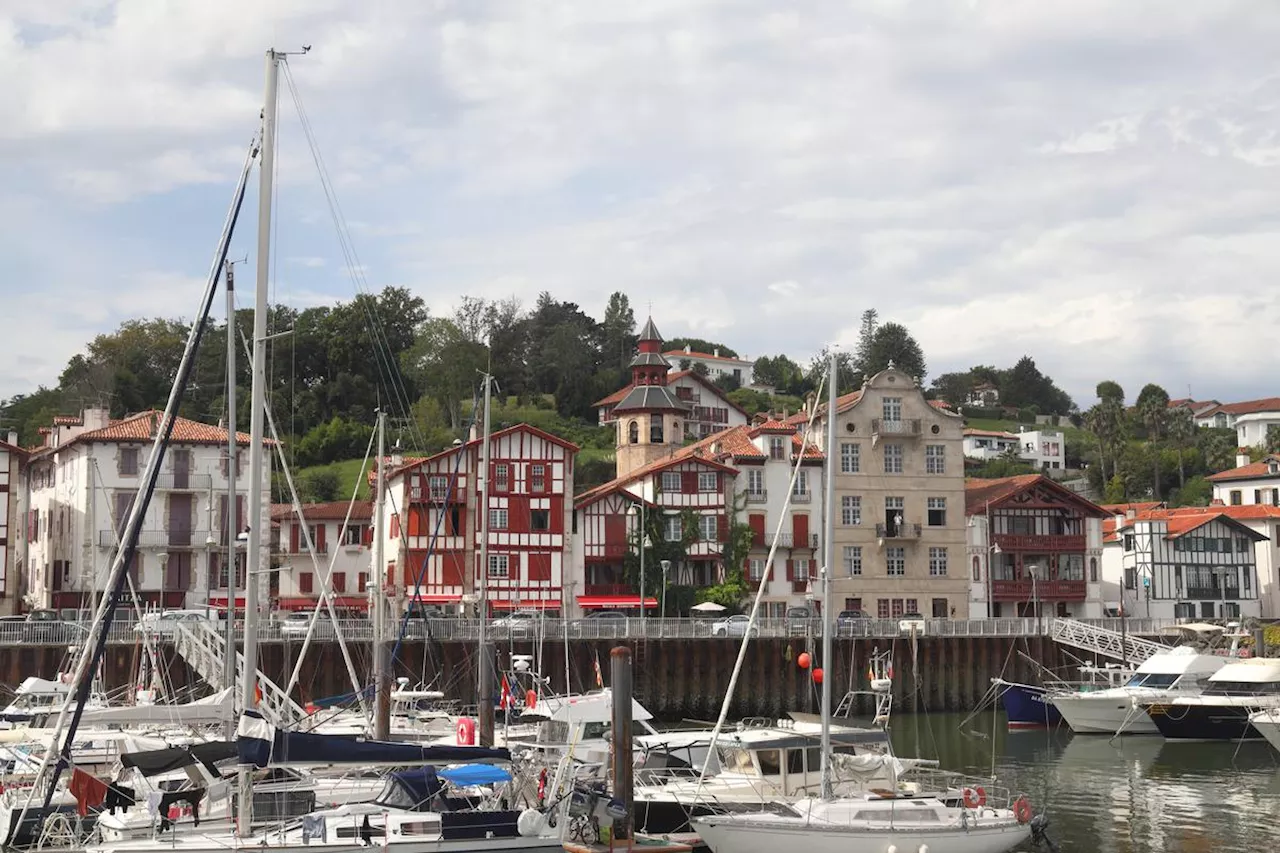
[892, 713, 1280, 853]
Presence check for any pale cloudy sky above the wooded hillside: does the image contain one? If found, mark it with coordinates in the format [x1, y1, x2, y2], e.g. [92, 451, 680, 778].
[0, 0, 1280, 405]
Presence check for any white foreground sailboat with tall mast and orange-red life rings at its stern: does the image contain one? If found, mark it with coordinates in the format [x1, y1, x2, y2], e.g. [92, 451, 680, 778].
[691, 351, 1046, 853]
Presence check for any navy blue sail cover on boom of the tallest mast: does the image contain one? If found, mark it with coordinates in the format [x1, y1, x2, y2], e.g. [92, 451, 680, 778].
[236, 711, 511, 767]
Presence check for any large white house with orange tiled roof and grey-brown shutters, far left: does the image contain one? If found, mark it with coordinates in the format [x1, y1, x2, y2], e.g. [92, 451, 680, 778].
[26, 409, 270, 610]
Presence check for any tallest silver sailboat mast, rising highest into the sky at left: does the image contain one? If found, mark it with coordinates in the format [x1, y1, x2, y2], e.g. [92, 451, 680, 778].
[237, 50, 283, 838]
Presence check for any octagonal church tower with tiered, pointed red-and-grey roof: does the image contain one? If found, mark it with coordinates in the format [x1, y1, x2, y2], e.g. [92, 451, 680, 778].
[613, 318, 689, 476]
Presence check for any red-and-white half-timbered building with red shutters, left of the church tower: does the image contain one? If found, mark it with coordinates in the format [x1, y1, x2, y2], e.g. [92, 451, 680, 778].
[385, 424, 577, 612]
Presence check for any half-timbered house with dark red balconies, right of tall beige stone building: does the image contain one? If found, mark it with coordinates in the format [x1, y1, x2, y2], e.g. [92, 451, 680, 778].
[965, 474, 1108, 619]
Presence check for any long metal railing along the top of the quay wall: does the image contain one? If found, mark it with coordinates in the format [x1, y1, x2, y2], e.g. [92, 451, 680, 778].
[0, 616, 1194, 645]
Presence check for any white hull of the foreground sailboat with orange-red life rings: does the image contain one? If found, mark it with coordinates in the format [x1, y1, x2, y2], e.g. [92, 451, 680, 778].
[694, 817, 1032, 853]
